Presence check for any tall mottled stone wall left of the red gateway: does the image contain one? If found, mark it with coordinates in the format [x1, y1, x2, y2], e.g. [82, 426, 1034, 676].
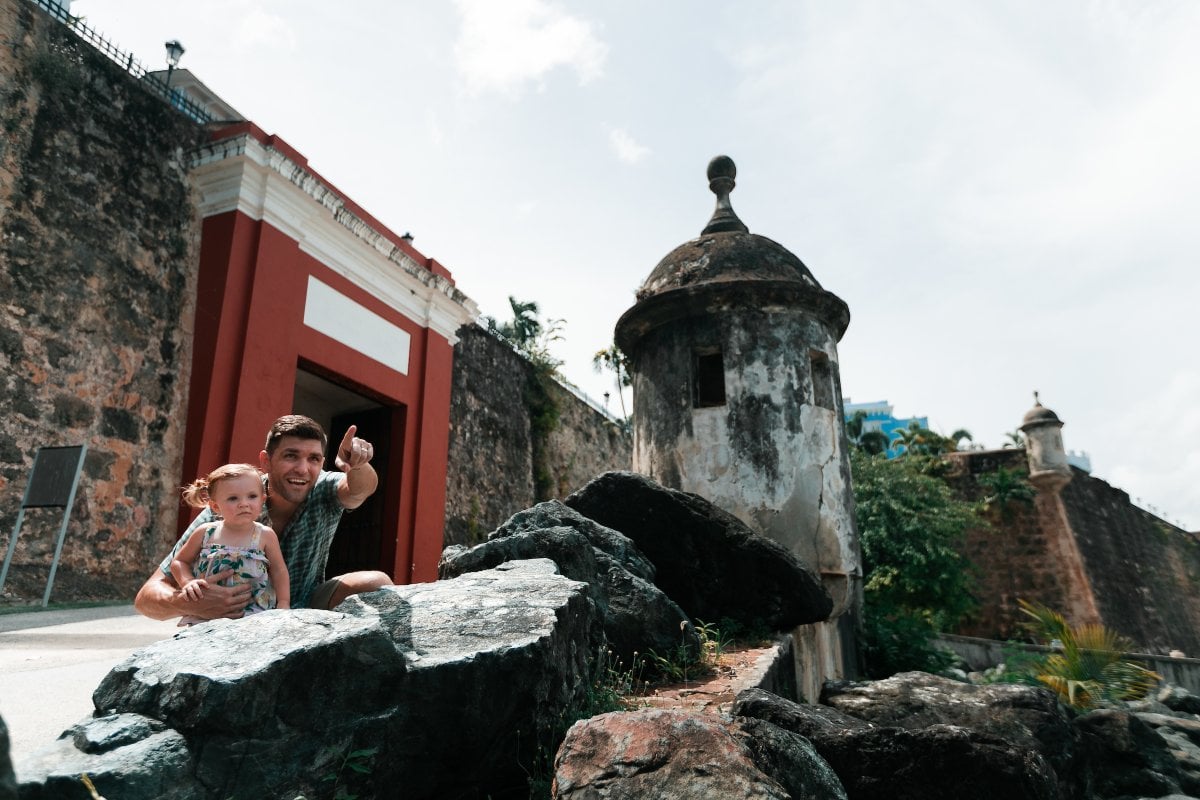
[0, 0, 203, 600]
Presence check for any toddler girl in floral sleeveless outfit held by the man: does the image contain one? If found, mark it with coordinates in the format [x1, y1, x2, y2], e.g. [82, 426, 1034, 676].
[170, 464, 290, 625]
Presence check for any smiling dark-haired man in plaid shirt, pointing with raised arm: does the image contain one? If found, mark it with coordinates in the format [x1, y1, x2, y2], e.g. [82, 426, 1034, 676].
[133, 415, 391, 619]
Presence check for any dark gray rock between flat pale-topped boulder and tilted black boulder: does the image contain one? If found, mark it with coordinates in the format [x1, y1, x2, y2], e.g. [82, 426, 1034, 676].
[438, 513, 700, 667]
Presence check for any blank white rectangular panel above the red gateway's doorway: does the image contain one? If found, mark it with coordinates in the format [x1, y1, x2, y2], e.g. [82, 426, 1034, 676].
[304, 275, 413, 375]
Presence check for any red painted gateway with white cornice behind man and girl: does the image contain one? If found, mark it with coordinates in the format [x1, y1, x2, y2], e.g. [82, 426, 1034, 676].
[181, 122, 476, 583]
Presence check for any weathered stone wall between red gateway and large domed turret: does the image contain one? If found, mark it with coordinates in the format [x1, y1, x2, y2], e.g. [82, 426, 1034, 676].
[445, 325, 631, 545]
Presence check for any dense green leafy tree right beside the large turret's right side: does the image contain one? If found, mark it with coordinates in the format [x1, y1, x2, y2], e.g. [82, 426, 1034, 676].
[851, 450, 979, 678]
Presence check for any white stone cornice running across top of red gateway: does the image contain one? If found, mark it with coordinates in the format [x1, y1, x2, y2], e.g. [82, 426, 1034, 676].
[184, 133, 479, 344]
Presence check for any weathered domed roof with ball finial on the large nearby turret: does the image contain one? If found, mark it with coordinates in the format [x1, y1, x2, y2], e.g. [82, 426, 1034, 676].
[637, 156, 821, 300]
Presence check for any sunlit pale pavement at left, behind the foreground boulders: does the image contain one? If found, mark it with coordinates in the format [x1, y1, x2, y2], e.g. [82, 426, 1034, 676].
[0, 606, 179, 770]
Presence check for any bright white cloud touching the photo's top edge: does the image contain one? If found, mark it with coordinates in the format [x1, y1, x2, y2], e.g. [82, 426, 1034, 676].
[454, 0, 608, 94]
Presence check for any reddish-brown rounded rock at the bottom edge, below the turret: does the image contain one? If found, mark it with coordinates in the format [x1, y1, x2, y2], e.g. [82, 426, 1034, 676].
[553, 709, 846, 800]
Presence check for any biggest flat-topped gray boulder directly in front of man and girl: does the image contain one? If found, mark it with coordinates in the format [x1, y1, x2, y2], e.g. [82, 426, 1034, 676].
[20, 560, 595, 800]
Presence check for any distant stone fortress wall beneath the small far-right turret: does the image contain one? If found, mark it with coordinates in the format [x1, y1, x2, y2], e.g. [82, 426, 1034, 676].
[950, 450, 1200, 655]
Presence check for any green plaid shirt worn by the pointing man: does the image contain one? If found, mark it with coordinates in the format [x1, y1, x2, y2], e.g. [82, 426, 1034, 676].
[158, 471, 344, 608]
